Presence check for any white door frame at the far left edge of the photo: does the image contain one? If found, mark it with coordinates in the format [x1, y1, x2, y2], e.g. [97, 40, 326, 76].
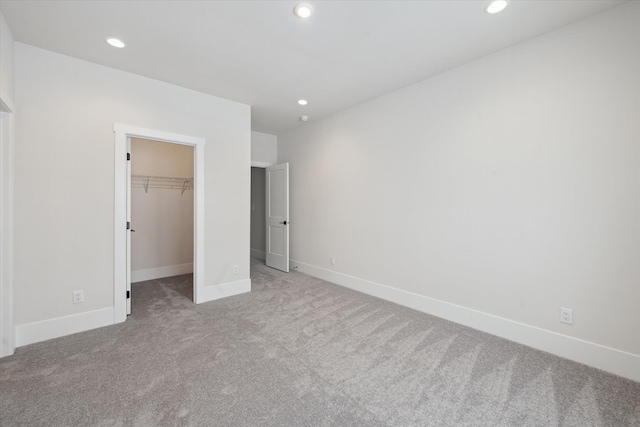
[0, 93, 16, 357]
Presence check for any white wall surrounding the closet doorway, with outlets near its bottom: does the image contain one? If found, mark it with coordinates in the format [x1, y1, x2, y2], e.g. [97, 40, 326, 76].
[15, 43, 251, 331]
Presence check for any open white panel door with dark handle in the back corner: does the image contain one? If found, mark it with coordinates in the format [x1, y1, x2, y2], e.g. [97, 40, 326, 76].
[265, 163, 289, 272]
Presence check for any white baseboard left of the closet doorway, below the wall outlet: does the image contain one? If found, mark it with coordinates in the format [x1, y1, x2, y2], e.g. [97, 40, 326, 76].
[16, 307, 114, 347]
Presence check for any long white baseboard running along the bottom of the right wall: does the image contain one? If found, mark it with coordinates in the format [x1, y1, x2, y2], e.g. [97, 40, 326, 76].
[290, 260, 640, 382]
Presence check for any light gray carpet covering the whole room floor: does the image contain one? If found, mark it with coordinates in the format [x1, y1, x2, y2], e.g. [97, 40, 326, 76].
[0, 262, 640, 427]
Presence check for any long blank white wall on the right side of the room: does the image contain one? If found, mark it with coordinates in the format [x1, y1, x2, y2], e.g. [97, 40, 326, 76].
[278, 2, 640, 380]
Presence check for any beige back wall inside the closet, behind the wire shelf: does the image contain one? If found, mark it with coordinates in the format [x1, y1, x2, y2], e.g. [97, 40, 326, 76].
[131, 138, 194, 282]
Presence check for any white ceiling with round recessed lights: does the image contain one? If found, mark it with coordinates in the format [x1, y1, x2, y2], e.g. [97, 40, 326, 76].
[0, 0, 624, 134]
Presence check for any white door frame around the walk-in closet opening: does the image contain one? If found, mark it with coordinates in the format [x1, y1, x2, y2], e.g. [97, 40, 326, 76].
[113, 123, 206, 323]
